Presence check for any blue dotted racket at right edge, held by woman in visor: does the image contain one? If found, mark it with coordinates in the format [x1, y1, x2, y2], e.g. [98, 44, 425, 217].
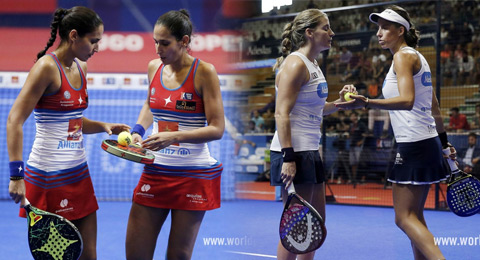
[444, 150, 480, 217]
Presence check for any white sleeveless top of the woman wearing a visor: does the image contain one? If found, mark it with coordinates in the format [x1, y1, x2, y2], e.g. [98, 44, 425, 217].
[382, 47, 438, 143]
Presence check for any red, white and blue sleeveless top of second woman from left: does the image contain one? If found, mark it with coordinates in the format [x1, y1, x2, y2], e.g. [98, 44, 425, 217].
[149, 59, 217, 166]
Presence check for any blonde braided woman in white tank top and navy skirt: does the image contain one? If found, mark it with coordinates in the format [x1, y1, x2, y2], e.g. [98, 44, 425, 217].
[270, 9, 356, 259]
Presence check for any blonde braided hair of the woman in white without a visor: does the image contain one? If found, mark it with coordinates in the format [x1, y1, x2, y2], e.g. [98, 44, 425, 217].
[273, 9, 328, 70]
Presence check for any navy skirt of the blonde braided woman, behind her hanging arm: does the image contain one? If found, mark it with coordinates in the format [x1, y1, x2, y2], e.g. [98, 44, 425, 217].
[270, 151, 325, 186]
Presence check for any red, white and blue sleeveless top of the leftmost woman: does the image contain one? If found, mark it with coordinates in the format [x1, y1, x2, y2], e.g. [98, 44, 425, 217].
[27, 53, 88, 172]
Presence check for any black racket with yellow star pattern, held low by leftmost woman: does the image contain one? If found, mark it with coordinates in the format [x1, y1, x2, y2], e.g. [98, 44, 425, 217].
[23, 198, 83, 260]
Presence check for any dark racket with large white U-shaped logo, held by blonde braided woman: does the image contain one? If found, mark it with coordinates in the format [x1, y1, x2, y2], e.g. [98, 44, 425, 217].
[279, 183, 327, 254]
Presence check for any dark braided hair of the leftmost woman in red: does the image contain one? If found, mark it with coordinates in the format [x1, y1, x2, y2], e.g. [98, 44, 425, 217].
[37, 6, 103, 60]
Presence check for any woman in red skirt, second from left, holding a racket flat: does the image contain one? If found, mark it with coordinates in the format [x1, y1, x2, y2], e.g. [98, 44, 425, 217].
[126, 9, 225, 260]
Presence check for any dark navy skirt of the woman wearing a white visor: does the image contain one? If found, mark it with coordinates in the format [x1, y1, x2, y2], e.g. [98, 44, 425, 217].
[388, 137, 450, 185]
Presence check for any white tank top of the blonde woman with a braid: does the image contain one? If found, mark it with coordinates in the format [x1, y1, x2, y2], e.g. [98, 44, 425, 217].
[270, 52, 328, 152]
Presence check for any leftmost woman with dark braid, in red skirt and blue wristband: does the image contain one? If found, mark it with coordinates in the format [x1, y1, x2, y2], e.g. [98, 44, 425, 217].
[7, 6, 129, 259]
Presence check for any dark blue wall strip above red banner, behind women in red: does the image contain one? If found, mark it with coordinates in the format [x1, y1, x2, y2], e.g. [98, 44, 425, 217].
[0, 0, 231, 32]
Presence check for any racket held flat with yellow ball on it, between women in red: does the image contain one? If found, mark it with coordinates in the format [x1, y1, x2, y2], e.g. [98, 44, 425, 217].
[102, 139, 155, 164]
